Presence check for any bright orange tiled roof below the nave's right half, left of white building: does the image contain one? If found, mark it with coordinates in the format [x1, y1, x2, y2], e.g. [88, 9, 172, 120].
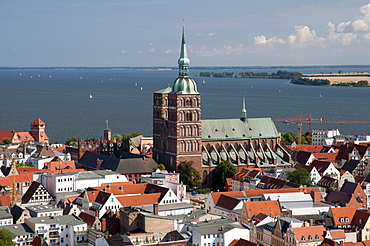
[245, 201, 281, 218]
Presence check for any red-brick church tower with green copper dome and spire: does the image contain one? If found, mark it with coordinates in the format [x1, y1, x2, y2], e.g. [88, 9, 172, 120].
[153, 28, 202, 171]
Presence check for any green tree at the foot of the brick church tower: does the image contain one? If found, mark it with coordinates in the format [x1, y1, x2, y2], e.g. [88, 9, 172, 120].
[177, 161, 202, 190]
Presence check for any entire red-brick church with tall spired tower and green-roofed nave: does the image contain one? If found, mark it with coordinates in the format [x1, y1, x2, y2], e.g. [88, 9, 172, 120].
[153, 28, 291, 186]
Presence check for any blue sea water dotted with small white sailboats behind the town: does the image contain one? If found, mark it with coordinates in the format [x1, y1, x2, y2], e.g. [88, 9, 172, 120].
[0, 67, 370, 143]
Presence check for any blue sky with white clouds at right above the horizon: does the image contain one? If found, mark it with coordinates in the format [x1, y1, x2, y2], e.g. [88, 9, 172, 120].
[0, 0, 370, 67]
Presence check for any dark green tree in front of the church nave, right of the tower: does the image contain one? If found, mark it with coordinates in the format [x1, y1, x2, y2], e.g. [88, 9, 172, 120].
[212, 161, 237, 191]
